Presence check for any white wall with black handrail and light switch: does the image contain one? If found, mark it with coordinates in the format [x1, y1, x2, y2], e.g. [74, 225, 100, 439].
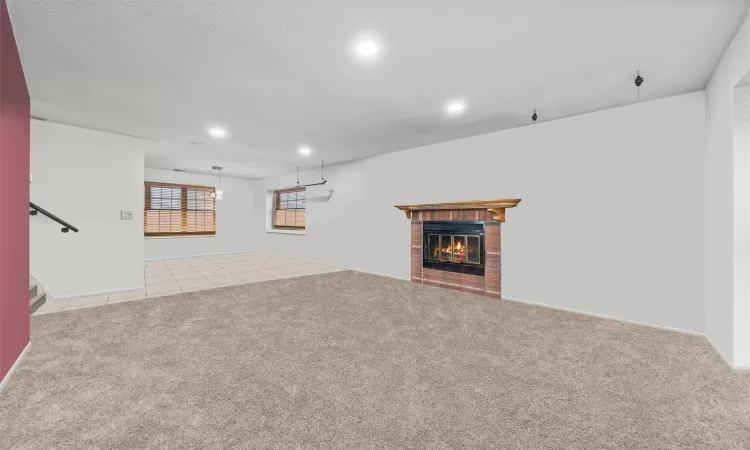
[31, 120, 149, 297]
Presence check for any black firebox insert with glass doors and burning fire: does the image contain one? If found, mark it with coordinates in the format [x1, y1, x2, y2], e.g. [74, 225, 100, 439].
[422, 221, 485, 276]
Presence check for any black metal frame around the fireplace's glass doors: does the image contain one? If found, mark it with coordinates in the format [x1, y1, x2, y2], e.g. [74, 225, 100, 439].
[422, 221, 485, 276]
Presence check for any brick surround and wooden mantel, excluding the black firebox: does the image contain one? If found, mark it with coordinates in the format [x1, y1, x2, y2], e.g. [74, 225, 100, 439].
[396, 199, 521, 299]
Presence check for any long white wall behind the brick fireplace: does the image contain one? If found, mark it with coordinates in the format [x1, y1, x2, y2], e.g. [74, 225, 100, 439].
[253, 92, 705, 332]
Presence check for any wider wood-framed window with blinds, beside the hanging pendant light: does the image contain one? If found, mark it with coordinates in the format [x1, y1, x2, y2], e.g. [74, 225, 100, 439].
[143, 182, 216, 236]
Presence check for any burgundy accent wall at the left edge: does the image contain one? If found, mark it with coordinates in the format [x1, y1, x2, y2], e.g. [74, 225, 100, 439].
[0, 0, 30, 380]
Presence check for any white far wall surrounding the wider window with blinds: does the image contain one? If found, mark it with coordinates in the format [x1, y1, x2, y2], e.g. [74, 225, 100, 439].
[141, 169, 256, 259]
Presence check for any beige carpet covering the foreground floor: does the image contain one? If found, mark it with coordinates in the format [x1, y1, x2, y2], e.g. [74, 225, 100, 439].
[0, 272, 750, 449]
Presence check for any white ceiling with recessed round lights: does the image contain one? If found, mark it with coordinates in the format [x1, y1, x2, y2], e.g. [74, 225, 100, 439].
[8, 0, 750, 178]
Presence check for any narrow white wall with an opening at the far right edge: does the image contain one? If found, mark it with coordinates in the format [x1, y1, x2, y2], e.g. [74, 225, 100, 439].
[703, 10, 750, 366]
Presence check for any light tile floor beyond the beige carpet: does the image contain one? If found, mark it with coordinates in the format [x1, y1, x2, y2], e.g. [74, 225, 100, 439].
[33, 252, 344, 316]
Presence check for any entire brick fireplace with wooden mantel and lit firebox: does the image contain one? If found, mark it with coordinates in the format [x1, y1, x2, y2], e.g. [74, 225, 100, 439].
[396, 199, 521, 299]
